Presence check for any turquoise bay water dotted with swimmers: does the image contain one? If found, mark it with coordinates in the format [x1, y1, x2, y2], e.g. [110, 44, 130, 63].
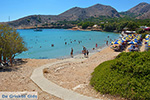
[16, 29, 119, 59]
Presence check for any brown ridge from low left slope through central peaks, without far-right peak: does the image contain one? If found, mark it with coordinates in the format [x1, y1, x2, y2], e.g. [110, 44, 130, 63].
[5, 4, 120, 28]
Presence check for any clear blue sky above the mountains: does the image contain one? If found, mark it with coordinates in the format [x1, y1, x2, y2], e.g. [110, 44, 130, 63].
[0, 0, 150, 22]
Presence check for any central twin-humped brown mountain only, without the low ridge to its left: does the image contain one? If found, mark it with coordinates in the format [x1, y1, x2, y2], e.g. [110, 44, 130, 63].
[58, 4, 120, 20]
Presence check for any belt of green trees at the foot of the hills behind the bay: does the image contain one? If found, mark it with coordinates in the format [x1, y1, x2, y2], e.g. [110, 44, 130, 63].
[54, 16, 150, 32]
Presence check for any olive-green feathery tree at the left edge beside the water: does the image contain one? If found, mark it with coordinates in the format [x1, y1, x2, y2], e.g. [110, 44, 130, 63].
[0, 25, 27, 65]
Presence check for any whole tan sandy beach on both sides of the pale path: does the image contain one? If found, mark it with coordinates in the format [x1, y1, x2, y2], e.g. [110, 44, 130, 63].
[0, 42, 144, 100]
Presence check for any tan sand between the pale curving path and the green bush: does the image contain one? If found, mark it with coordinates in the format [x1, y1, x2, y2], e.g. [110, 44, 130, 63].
[44, 47, 123, 100]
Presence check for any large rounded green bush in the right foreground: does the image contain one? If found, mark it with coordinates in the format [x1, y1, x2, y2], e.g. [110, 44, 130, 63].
[90, 51, 150, 100]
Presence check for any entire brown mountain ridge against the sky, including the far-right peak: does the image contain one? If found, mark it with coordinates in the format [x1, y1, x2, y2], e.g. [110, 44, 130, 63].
[2, 2, 150, 27]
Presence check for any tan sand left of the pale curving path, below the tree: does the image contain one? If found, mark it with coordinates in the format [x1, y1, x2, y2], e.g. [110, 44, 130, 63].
[0, 59, 61, 100]
